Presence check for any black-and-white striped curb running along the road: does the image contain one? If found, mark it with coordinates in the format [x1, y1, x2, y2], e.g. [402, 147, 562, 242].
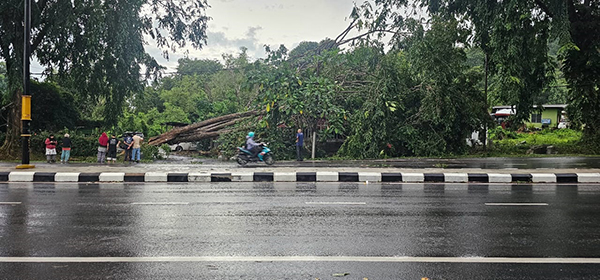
[0, 171, 600, 184]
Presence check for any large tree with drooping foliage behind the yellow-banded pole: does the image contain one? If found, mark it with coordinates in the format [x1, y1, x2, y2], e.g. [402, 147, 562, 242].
[0, 0, 209, 154]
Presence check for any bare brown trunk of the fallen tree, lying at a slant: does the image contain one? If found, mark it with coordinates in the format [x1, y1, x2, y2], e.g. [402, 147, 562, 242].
[148, 111, 258, 146]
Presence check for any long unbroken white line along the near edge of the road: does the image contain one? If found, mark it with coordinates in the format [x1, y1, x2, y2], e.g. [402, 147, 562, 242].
[0, 256, 600, 264]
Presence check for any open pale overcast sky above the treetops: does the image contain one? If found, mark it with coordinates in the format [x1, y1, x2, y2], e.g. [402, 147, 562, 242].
[146, 0, 362, 71]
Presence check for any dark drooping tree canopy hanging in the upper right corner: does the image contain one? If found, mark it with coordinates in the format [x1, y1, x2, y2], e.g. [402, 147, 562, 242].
[352, 0, 600, 144]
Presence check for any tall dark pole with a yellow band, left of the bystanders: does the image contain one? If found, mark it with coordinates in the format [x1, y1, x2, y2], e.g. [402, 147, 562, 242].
[17, 0, 35, 169]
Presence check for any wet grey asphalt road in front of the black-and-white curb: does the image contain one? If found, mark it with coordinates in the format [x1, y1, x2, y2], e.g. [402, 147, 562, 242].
[0, 183, 600, 280]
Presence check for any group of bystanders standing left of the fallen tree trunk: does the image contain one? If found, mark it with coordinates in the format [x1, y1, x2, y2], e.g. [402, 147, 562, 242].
[44, 132, 144, 163]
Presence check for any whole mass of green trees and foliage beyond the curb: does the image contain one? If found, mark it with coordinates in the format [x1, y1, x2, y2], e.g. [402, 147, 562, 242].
[0, 0, 600, 162]
